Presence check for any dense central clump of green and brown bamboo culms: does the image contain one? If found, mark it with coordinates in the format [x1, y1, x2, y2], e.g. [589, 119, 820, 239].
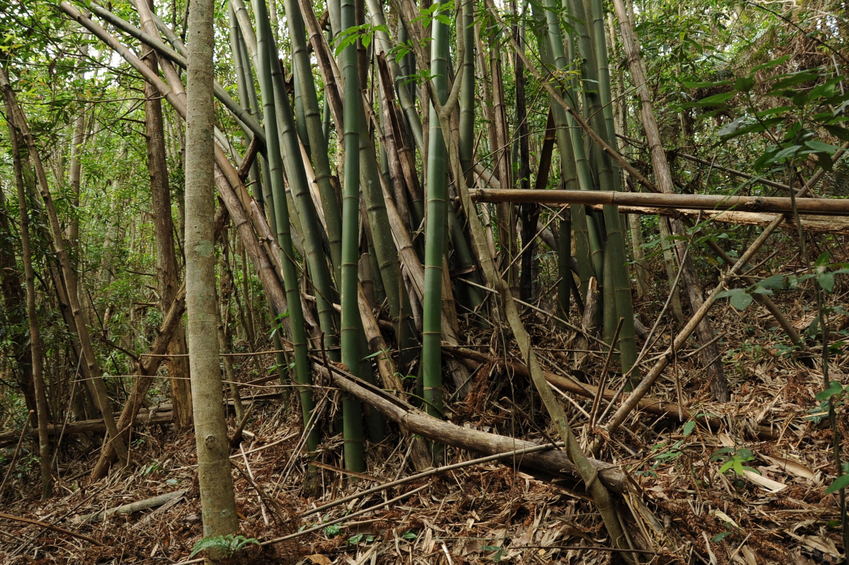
[49, 0, 652, 470]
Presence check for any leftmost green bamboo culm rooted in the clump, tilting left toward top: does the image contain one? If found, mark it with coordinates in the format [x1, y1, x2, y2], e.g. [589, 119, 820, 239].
[254, 0, 319, 450]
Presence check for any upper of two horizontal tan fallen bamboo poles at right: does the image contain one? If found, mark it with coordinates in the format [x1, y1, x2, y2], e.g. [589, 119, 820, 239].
[469, 188, 849, 216]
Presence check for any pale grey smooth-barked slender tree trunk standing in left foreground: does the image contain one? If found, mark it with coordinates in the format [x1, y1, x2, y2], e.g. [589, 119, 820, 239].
[185, 0, 238, 536]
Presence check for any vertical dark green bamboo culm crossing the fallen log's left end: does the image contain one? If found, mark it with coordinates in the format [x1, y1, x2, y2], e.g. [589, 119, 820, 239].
[338, 0, 366, 472]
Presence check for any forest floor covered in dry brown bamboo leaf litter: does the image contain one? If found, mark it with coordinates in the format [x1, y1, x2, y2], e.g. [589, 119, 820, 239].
[0, 270, 849, 565]
